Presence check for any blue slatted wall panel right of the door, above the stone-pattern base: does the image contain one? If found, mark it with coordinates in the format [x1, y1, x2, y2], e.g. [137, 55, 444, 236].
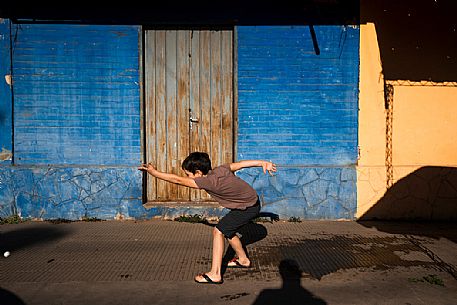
[237, 26, 359, 166]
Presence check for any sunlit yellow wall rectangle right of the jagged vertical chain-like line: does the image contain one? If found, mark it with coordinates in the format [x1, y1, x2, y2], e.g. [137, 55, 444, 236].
[393, 86, 457, 167]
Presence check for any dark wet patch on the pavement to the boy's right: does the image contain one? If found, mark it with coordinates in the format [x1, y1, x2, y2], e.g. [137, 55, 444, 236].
[256, 235, 436, 280]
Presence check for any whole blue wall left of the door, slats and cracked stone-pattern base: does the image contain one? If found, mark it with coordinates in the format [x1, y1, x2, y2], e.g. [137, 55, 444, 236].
[0, 21, 148, 219]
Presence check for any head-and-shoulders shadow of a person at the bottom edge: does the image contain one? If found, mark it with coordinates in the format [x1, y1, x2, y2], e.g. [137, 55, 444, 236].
[253, 259, 327, 305]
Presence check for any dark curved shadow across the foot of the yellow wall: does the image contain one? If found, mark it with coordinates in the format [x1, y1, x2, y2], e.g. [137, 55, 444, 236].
[360, 166, 457, 221]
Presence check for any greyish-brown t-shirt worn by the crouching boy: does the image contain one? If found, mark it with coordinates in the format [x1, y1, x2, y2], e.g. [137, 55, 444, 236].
[195, 164, 257, 210]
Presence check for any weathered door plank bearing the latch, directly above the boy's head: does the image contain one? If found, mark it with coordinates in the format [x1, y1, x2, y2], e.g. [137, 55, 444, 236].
[189, 31, 203, 201]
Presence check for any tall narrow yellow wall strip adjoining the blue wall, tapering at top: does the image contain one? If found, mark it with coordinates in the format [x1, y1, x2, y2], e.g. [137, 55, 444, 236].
[356, 23, 386, 218]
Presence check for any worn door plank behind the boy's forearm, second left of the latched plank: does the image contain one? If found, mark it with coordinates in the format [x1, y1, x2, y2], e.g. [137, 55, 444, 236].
[165, 31, 179, 199]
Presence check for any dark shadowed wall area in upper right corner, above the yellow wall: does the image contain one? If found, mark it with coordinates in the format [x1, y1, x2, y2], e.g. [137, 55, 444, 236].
[360, 0, 457, 82]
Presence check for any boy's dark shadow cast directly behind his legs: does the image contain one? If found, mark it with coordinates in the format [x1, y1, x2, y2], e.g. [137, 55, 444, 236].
[221, 218, 267, 274]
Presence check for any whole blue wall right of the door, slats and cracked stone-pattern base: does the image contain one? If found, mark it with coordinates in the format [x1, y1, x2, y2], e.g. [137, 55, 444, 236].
[233, 26, 359, 219]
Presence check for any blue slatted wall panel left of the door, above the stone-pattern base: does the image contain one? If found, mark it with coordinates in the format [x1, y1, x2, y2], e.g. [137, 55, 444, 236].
[13, 24, 141, 165]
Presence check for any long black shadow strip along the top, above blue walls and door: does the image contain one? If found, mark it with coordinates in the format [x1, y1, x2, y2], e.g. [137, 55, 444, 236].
[0, 0, 360, 26]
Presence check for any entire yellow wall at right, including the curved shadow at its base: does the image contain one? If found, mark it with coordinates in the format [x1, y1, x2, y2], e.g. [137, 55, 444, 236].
[356, 23, 457, 219]
